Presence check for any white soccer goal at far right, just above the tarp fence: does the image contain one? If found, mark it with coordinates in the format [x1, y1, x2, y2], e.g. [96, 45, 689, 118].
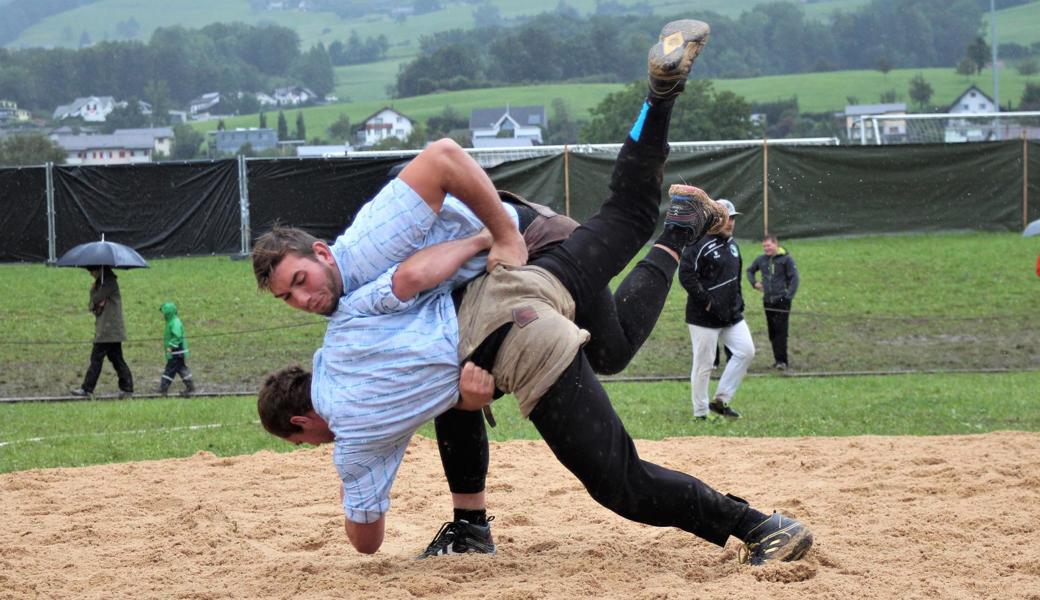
[849, 110, 1040, 146]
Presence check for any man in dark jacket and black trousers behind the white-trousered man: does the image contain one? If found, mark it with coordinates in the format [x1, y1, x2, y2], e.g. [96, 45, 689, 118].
[748, 235, 798, 371]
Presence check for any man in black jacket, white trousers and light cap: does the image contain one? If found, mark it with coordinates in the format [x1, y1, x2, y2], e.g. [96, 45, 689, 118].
[679, 200, 755, 420]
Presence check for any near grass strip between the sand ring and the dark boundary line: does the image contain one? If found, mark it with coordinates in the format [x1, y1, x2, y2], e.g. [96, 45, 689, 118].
[0, 371, 1040, 473]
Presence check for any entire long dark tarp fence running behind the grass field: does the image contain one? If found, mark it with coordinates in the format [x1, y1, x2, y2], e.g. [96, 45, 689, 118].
[0, 140, 1040, 262]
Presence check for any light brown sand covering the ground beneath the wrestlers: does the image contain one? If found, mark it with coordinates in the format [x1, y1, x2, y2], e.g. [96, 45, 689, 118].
[0, 432, 1040, 600]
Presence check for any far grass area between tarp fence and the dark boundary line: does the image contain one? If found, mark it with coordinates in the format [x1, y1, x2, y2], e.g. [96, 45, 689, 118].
[0, 234, 1040, 397]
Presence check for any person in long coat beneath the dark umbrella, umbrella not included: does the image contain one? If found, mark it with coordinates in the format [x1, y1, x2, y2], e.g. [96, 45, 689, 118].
[71, 266, 133, 398]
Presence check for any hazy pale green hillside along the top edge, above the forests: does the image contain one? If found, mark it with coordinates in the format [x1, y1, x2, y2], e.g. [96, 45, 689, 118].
[6, 0, 867, 50]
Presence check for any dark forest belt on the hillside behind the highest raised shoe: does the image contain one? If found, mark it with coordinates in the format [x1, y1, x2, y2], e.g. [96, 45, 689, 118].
[396, 0, 990, 97]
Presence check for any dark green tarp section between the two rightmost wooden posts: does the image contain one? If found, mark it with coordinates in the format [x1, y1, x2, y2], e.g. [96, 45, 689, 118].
[759, 141, 1022, 237]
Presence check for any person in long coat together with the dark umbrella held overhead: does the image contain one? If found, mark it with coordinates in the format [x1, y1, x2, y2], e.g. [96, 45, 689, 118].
[58, 237, 148, 398]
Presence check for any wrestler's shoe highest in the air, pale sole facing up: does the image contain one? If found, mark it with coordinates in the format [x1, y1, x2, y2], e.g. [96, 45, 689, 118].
[647, 19, 711, 99]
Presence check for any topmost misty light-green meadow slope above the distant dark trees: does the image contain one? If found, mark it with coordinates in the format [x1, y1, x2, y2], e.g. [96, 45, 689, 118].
[8, 0, 866, 50]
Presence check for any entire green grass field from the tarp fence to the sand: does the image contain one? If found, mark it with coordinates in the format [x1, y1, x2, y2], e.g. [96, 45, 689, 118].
[0, 234, 1040, 472]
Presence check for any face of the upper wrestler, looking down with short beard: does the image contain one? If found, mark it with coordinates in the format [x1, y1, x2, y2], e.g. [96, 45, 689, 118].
[270, 242, 343, 316]
